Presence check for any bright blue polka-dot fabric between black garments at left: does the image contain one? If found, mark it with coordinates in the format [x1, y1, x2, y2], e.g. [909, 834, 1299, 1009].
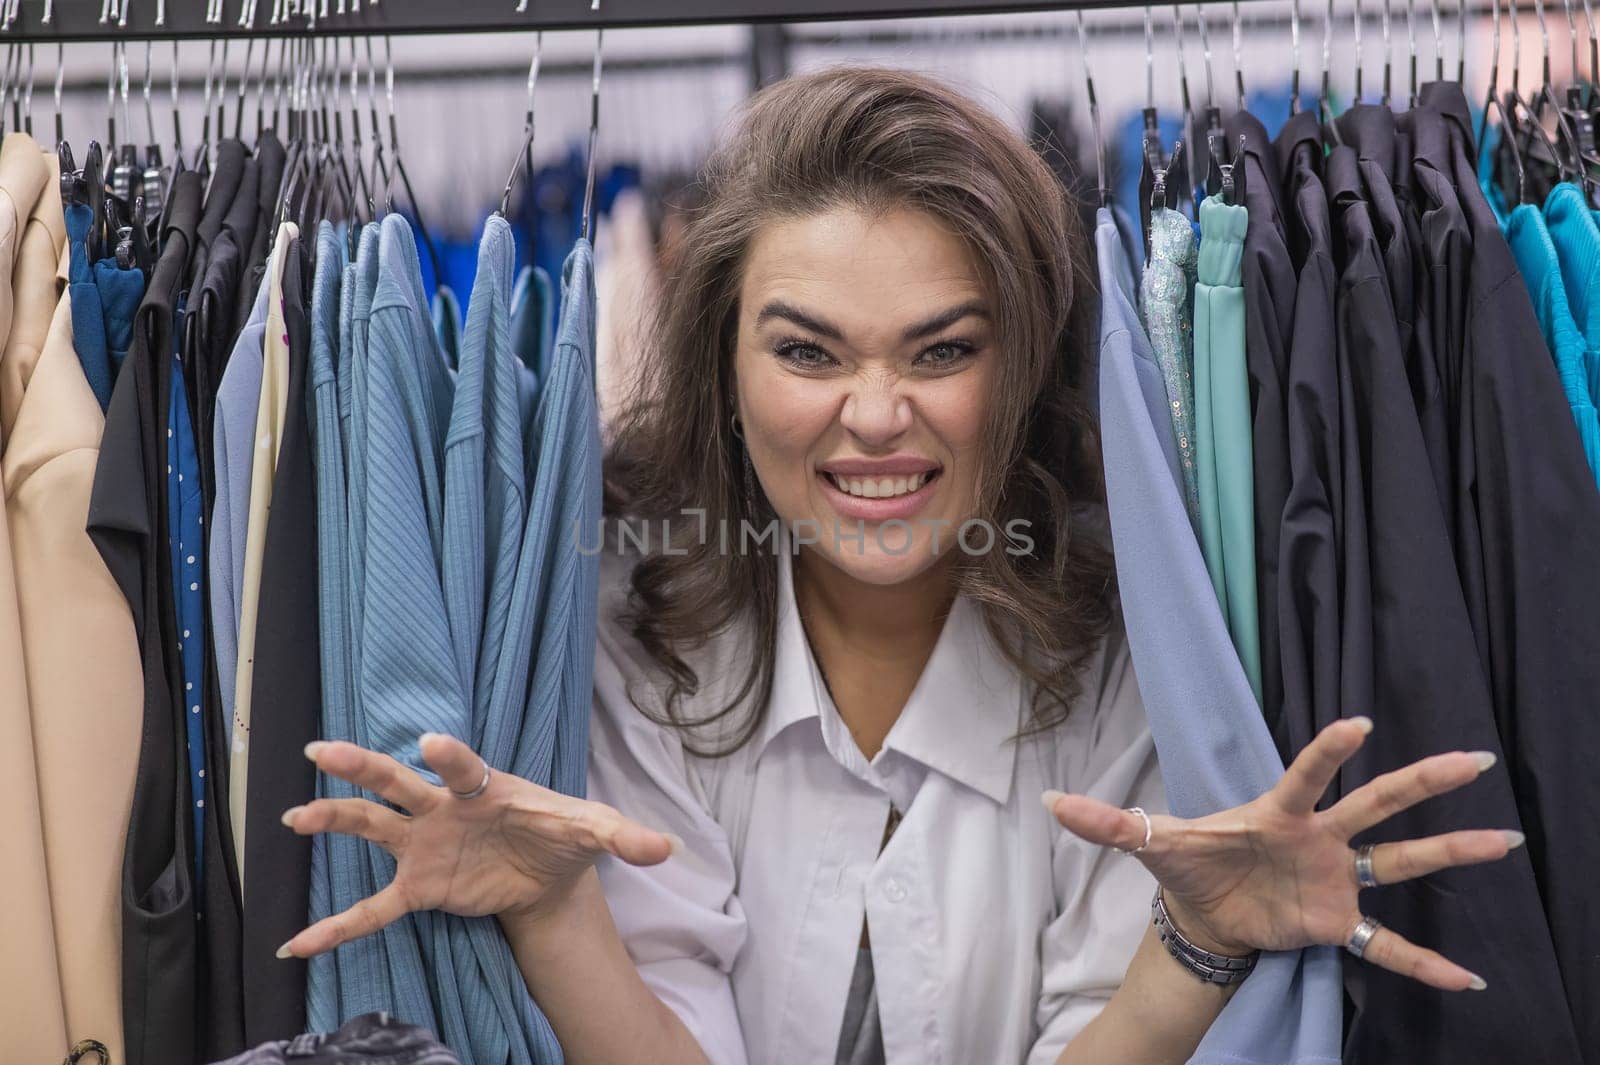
[166, 295, 206, 889]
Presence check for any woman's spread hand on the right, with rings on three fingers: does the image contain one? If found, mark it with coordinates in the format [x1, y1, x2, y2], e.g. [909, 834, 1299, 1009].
[1046, 718, 1522, 991]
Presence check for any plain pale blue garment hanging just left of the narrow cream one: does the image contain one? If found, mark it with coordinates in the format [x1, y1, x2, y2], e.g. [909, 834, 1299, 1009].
[206, 256, 272, 740]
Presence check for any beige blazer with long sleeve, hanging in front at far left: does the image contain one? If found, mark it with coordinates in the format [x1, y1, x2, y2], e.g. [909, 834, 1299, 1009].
[0, 136, 144, 1062]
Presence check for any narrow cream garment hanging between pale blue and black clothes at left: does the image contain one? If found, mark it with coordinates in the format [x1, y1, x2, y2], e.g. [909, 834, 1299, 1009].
[227, 222, 299, 892]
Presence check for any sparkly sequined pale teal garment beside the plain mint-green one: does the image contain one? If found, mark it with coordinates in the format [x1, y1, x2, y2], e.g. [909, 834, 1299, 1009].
[1139, 208, 1200, 523]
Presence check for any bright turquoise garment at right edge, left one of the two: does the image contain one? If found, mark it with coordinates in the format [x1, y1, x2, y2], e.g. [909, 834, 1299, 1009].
[1506, 203, 1600, 485]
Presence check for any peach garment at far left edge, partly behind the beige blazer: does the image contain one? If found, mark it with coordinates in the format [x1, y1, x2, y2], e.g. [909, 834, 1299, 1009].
[0, 133, 69, 1062]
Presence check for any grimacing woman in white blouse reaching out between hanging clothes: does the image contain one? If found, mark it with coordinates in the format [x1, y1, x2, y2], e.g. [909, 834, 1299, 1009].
[285, 70, 1520, 1065]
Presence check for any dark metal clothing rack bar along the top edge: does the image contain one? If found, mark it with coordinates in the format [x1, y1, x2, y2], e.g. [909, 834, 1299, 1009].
[0, 0, 1280, 43]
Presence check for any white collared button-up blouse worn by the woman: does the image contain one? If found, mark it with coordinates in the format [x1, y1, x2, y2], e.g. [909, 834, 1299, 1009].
[589, 540, 1166, 1065]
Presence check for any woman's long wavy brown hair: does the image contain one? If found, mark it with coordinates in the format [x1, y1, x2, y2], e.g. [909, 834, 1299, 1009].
[606, 67, 1114, 756]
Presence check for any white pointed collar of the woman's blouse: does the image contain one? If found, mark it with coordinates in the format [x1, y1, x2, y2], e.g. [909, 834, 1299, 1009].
[754, 537, 1022, 803]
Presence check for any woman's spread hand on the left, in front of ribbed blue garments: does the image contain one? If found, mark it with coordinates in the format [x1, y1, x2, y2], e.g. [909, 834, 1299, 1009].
[278, 734, 682, 958]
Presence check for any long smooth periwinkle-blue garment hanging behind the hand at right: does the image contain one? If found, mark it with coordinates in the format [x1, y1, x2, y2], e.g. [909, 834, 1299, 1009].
[1096, 209, 1344, 1065]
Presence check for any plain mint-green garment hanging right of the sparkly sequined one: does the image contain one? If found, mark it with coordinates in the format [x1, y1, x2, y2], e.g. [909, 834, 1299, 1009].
[1194, 197, 1261, 704]
